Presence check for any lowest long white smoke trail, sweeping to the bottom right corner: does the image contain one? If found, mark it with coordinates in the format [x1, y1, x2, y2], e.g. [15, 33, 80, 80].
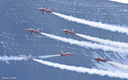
[33, 59, 128, 79]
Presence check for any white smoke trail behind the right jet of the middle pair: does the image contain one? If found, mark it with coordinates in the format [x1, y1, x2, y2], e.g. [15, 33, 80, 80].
[76, 33, 128, 48]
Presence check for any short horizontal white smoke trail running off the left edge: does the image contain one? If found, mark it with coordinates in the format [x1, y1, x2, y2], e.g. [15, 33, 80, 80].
[0, 55, 26, 61]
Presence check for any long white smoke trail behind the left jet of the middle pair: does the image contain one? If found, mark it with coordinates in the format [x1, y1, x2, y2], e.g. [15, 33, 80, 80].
[41, 33, 128, 53]
